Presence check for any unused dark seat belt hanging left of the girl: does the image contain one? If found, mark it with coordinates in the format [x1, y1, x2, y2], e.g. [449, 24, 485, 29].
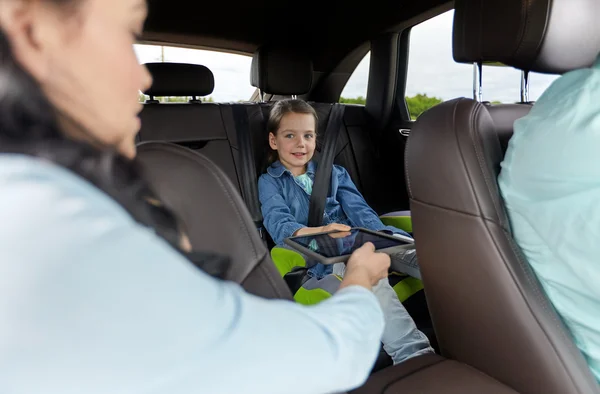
[232, 104, 264, 239]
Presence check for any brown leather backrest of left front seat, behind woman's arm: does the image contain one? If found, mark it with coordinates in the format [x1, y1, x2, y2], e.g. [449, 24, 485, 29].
[138, 142, 292, 299]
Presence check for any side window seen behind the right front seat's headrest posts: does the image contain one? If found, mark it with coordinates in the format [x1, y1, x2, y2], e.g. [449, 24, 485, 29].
[406, 10, 557, 119]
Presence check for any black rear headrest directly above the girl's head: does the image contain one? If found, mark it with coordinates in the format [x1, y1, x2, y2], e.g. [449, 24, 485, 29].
[250, 47, 313, 96]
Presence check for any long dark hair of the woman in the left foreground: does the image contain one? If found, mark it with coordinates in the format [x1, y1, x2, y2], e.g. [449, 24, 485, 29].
[0, 11, 180, 248]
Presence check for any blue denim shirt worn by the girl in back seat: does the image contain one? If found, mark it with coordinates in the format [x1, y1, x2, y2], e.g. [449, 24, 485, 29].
[258, 161, 409, 277]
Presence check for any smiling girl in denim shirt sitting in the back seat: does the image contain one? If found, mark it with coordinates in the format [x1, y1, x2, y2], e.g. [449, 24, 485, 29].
[258, 99, 433, 364]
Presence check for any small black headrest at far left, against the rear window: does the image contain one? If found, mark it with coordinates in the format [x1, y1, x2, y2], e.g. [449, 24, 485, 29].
[144, 63, 215, 97]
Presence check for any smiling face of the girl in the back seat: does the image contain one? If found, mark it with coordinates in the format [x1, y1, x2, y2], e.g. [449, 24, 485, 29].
[269, 112, 317, 176]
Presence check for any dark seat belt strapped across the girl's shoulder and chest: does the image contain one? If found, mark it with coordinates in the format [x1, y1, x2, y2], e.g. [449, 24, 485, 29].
[308, 103, 346, 227]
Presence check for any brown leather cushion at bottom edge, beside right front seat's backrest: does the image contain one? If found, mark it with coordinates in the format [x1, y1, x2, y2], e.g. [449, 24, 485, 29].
[351, 355, 516, 394]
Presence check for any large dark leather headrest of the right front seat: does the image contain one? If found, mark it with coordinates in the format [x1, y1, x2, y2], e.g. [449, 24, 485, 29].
[453, 0, 600, 74]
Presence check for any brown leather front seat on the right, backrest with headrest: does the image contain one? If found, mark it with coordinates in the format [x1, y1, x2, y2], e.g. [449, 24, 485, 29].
[406, 0, 600, 394]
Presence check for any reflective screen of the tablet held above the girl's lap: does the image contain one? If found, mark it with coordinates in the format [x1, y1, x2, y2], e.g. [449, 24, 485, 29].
[292, 229, 409, 257]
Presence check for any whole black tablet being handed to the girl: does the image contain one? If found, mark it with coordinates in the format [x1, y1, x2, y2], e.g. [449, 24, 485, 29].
[284, 228, 414, 264]
